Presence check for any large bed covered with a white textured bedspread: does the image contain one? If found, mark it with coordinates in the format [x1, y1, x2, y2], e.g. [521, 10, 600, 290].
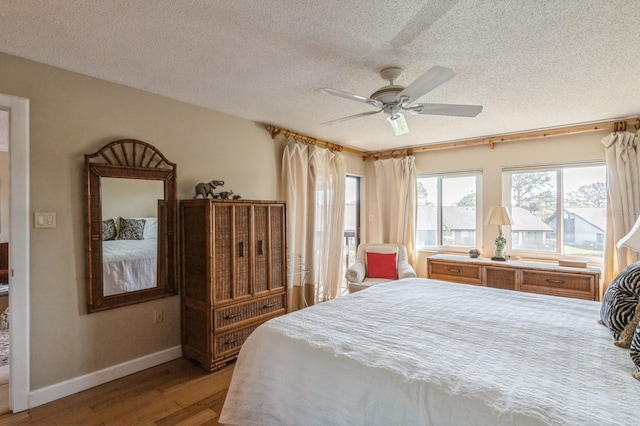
[220, 278, 640, 425]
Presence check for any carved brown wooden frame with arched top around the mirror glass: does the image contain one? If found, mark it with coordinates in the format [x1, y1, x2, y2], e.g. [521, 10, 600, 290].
[84, 139, 178, 313]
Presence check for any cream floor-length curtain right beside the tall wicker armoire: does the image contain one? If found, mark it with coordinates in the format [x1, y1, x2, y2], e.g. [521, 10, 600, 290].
[278, 135, 347, 308]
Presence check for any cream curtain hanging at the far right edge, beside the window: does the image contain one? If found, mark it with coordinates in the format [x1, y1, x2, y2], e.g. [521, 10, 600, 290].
[602, 132, 640, 288]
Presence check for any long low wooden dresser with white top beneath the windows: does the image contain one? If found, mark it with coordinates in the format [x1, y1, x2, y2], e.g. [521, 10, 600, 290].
[427, 254, 600, 300]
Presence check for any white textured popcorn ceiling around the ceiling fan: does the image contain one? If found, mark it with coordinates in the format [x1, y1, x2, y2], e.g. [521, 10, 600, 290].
[0, 0, 640, 151]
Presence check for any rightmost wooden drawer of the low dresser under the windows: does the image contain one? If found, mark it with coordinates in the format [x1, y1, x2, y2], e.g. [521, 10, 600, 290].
[520, 269, 597, 300]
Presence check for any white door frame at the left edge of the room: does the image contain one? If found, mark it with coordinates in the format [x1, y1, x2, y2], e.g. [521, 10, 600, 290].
[0, 94, 30, 413]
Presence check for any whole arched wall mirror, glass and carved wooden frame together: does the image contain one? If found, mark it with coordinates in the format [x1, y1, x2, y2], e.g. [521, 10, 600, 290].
[85, 139, 178, 312]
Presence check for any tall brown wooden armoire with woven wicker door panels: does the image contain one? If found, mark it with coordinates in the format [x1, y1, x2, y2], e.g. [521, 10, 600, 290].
[180, 199, 287, 371]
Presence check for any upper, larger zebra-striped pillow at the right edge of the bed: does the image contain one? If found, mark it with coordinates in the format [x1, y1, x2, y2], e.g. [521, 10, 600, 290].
[600, 262, 640, 348]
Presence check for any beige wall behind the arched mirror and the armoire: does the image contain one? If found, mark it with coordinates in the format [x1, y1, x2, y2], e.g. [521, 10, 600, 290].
[0, 53, 362, 391]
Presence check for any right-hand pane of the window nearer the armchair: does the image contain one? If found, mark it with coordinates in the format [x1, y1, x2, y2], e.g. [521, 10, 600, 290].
[442, 176, 476, 247]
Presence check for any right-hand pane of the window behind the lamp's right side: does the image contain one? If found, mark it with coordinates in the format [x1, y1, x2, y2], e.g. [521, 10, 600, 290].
[562, 166, 607, 257]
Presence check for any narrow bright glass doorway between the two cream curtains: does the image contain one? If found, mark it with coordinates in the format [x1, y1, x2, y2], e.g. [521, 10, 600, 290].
[340, 175, 360, 295]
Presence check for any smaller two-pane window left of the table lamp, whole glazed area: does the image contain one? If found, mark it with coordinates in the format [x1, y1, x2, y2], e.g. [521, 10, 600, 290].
[416, 171, 481, 249]
